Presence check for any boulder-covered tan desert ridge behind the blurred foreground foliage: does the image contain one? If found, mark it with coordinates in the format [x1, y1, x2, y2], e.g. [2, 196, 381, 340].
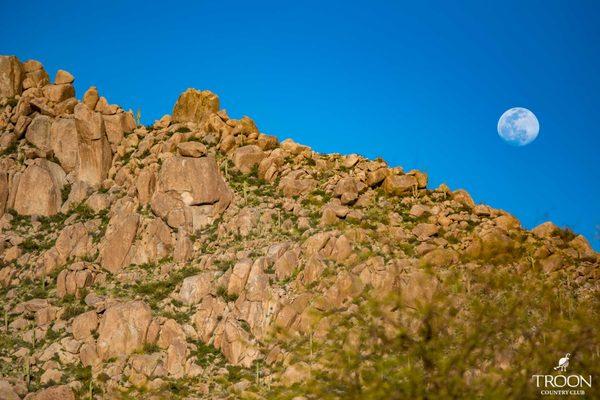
[0, 56, 600, 400]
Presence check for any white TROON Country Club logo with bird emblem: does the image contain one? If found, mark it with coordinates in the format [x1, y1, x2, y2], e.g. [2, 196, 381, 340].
[531, 353, 592, 396]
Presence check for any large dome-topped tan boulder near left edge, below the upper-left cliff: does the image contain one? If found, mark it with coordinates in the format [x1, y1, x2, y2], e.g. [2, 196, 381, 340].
[14, 158, 66, 216]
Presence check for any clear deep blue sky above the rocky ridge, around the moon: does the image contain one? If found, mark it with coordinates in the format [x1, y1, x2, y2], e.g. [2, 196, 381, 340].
[0, 0, 600, 249]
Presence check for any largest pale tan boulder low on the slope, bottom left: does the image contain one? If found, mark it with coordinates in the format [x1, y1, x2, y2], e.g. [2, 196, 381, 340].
[97, 301, 152, 360]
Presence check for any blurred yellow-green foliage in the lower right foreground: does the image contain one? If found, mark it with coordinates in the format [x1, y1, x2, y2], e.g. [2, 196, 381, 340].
[264, 267, 600, 400]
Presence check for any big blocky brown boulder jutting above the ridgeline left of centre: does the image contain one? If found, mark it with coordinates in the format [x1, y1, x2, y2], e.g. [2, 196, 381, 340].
[172, 89, 219, 123]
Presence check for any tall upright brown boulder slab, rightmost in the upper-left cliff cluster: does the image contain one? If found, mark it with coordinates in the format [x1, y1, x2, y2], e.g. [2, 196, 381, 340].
[75, 104, 112, 185]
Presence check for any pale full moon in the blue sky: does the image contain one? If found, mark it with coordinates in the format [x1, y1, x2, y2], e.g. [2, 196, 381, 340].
[498, 107, 540, 146]
